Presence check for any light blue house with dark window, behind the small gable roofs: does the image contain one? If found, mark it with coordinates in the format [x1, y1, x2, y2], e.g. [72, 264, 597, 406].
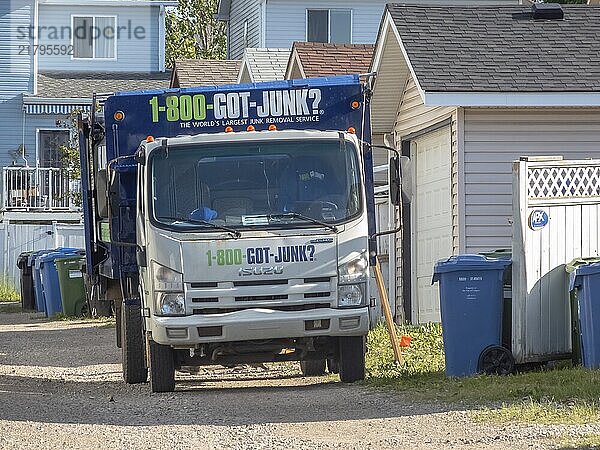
[217, 0, 520, 59]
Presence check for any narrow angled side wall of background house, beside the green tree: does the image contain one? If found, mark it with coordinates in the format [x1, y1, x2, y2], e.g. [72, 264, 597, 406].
[228, 0, 263, 59]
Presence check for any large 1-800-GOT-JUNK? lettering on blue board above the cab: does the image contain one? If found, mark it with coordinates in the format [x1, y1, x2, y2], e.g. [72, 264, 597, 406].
[149, 88, 324, 123]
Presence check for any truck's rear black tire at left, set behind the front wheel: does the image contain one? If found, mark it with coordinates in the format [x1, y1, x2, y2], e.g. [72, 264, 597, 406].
[120, 304, 148, 384]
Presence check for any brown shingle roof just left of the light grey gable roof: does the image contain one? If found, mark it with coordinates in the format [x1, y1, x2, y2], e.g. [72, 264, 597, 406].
[171, 59, 241, 87]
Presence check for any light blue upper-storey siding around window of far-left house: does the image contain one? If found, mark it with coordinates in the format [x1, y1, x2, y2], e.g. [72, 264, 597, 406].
[39, 5, 160, 72]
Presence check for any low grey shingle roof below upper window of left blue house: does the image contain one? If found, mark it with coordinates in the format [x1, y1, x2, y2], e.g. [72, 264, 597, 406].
[35, 72, 171, 99]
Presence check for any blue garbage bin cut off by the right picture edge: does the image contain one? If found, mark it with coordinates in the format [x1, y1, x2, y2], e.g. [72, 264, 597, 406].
[569, 263, 600, 369]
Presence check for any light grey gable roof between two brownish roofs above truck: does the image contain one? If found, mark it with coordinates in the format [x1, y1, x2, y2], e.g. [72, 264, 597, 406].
[237, 48, 291, 83]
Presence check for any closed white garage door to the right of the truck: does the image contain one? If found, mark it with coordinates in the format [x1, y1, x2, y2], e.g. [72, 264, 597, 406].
[411, 126, 452, 323]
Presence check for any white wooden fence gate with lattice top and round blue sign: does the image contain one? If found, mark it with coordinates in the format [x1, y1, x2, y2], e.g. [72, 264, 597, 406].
[512, 158, 600, 363]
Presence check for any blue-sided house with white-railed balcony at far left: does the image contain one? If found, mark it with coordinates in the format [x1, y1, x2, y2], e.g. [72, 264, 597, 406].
[0, 0, 177, 213]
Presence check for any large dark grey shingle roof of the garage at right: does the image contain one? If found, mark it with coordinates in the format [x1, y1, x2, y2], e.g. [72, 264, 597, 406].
[387, 4, 600, 92]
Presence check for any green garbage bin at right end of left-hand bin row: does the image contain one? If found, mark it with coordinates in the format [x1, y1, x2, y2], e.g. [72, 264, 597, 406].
[56, 256, 87, 316]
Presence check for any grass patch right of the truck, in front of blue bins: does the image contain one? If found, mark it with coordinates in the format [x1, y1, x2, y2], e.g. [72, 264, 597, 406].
[366, 325, 600, 423]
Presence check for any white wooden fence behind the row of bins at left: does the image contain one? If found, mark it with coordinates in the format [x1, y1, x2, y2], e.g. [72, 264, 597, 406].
[0, 222, 84, 296]
